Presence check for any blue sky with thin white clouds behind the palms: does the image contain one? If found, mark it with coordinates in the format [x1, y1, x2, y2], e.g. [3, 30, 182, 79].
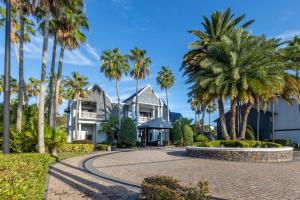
[0, 0, 300, 124]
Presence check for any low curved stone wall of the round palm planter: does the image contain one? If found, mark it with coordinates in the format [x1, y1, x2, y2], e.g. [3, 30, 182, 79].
[186, 147, 293, 162]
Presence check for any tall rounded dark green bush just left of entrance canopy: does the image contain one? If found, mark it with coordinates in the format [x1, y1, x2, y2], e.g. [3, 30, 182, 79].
[119, 117, 136, 147]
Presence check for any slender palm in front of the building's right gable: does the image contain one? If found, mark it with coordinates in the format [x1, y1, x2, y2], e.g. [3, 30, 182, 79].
[128, 47, 151, 126]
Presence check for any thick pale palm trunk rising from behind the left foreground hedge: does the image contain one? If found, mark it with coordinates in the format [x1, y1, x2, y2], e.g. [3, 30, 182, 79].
[38, 8, 50, 153]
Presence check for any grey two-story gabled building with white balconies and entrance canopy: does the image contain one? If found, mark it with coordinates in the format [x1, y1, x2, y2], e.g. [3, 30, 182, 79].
[65, 85, 178, 145]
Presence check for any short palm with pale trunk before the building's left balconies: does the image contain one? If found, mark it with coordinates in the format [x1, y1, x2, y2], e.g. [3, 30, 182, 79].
[65, 72, 89, 140]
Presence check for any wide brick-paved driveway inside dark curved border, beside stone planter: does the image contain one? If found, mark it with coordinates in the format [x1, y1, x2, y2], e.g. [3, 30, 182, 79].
[87, 149, 300, 199]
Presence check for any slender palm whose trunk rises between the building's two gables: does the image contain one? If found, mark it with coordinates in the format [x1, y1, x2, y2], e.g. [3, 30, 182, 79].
[100, 48, 129, 141]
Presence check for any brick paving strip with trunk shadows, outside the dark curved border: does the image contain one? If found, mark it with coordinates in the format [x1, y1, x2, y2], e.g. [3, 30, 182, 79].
[45, 153, 137, 200]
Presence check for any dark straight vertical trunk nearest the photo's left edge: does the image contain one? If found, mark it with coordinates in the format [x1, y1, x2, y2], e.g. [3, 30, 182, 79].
[3, 0, 11, 154]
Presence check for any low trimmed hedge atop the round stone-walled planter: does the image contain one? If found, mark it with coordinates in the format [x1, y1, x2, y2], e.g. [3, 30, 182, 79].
[194, 140, 282, 148]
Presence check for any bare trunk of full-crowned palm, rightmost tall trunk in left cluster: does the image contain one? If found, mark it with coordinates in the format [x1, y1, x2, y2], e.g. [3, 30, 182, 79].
[51, 43, 66, 129]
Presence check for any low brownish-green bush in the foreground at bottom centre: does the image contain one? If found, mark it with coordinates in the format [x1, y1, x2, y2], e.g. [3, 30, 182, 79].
[142, 176, 209, 200]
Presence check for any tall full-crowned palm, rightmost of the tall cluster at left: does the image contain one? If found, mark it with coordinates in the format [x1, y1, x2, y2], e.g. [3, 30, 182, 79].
[50, 0, 89, 129]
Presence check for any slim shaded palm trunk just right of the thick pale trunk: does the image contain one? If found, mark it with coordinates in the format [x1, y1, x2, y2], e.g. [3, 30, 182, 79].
[48, 34, 57, 128]
